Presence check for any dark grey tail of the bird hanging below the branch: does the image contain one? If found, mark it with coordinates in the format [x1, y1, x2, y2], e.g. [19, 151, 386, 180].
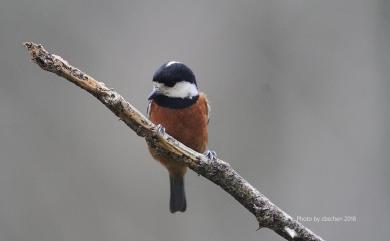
[169, 175, 187, 213]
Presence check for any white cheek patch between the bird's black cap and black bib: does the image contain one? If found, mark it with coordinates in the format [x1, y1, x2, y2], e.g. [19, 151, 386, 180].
[153, 81, 199, 99]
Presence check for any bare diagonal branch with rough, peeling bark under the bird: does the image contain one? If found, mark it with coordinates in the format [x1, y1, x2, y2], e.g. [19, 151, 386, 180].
[24, 42, 323, 240]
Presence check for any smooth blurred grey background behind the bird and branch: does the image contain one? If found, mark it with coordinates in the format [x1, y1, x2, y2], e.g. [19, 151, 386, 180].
[0, 0, 390, 241]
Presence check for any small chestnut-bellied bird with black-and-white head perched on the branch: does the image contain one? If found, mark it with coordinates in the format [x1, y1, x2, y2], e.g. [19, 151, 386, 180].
[147, 61, 216, 213]
